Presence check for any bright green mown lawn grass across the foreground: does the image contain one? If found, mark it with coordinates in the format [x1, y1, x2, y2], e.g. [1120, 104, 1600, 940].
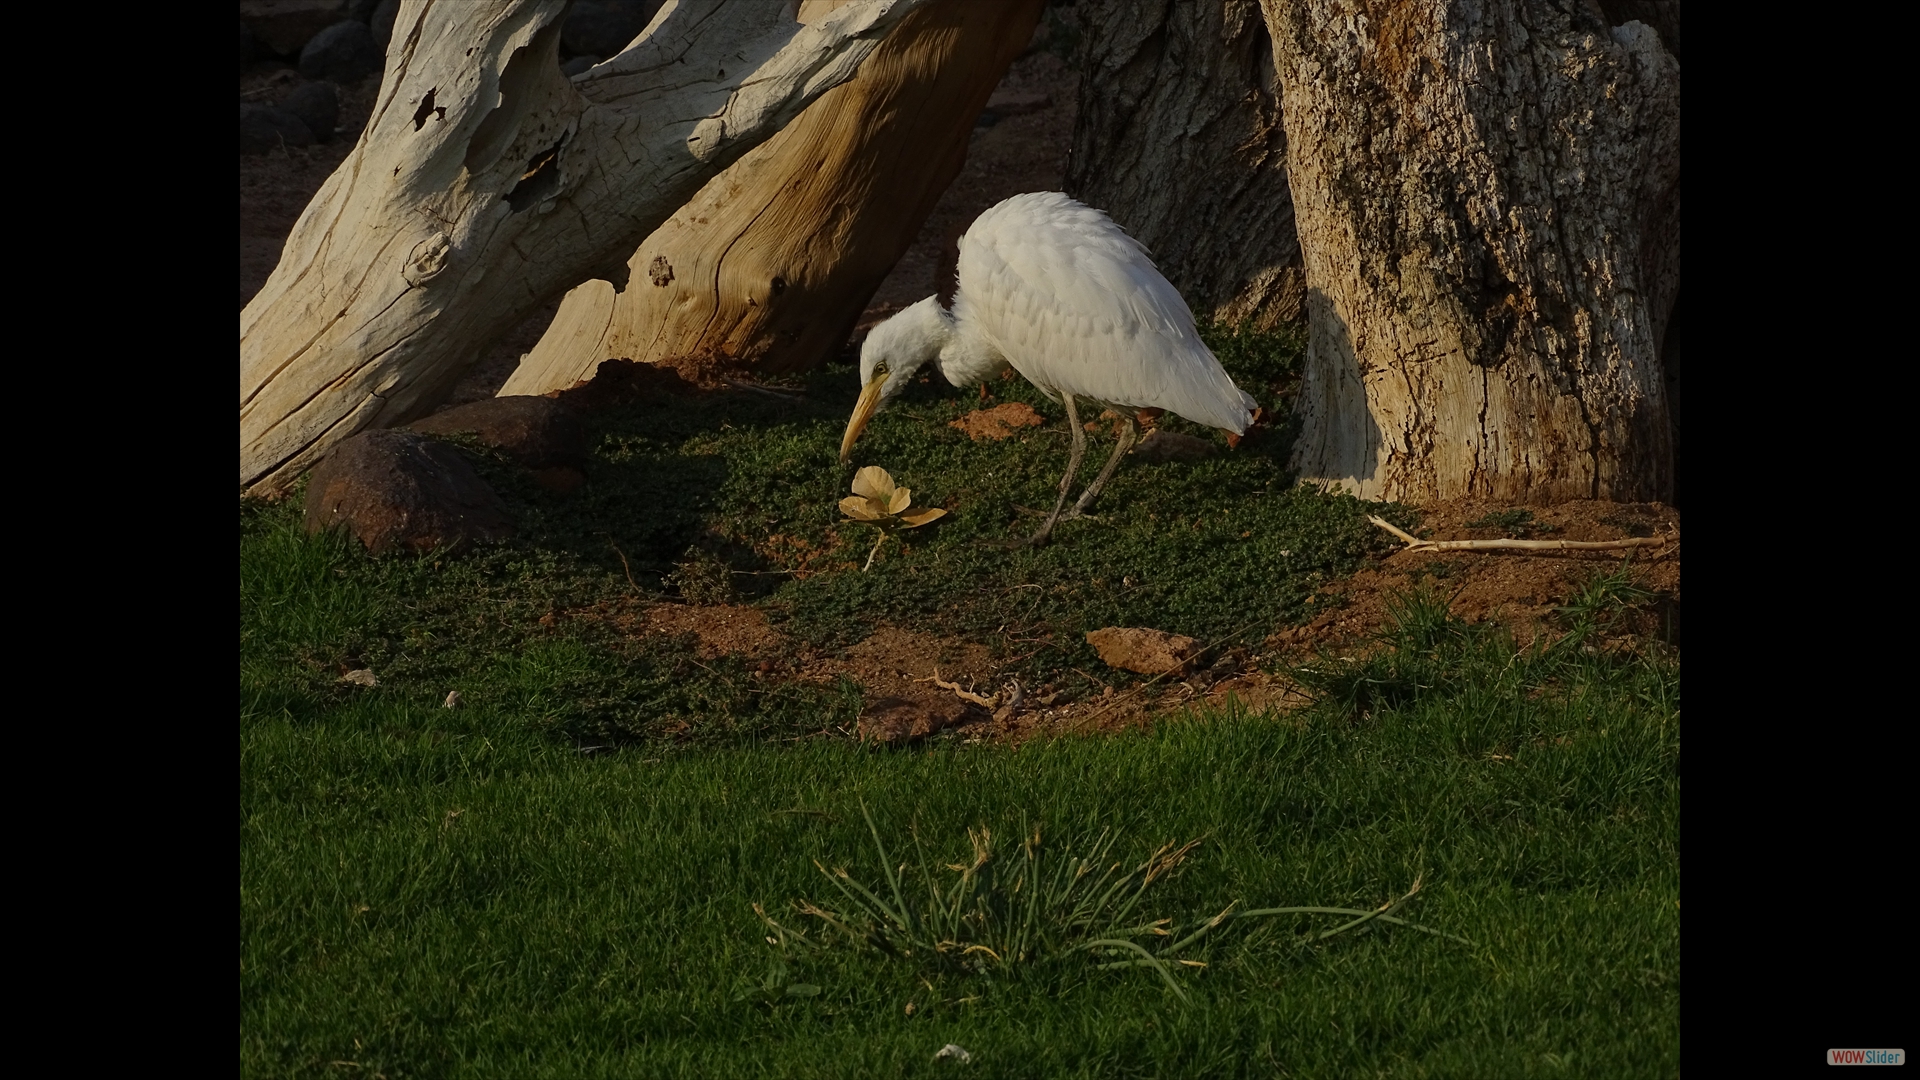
[240, 618, 1680, 1078]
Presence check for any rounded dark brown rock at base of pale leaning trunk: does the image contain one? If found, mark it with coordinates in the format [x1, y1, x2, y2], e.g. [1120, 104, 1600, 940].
[307, 430, 513, 553]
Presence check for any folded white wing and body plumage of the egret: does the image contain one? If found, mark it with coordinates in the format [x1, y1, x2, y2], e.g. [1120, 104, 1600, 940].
[954, 192, 1254, 432]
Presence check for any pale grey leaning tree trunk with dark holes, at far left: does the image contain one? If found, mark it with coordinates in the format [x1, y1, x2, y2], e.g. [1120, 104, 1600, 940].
[240, 0, 925, 494]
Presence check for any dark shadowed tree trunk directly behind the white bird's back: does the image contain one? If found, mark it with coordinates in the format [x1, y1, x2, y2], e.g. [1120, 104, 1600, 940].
[1066, 0, 1306, 329]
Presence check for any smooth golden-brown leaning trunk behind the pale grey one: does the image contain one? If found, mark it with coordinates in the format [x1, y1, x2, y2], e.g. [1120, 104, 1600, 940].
[501, 0, 1043, 394]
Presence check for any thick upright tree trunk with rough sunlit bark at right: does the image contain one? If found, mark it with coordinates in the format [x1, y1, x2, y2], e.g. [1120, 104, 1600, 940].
[1263, 0, 1680, 502]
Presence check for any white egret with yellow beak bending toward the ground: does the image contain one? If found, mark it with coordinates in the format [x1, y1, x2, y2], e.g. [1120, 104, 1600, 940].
[841, 192, 1256, 544]
